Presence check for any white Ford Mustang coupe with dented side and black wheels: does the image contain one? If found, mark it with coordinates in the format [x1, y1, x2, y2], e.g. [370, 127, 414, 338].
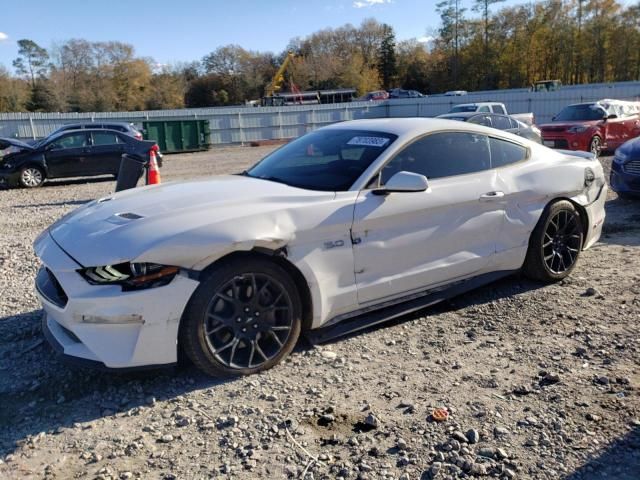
[35, 118, 607, 375]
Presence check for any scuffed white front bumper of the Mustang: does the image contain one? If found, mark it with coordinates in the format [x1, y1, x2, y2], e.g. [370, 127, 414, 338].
[34, 232, 198, 369]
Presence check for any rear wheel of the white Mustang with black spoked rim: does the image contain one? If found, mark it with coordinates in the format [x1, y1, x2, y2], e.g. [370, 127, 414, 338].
[523, 200, 584, 282]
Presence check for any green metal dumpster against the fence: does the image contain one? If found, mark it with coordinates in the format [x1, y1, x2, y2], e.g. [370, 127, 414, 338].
[142, 120, 211, 153]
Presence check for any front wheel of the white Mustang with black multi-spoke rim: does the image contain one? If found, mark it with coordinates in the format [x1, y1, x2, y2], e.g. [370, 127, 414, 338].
[179, 257, 302, 376]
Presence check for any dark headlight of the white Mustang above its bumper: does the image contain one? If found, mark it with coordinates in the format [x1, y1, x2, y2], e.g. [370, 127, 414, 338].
[78, 263, 179, 292]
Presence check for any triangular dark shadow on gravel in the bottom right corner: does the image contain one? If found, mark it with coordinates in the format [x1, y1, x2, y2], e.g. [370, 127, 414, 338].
[563, 426, 640, 480]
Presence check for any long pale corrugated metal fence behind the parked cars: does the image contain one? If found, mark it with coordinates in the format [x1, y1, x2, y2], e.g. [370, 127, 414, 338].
[0, 81, 640, 145]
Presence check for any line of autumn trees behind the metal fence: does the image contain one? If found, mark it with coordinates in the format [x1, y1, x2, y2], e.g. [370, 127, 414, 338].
[0, 0, 640, 112]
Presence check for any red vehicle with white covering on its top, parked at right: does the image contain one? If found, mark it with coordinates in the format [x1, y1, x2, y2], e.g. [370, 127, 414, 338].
[540, 100, 640, 155]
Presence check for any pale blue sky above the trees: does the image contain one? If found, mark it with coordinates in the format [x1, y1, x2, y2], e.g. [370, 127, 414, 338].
[0, 0, 634, 70]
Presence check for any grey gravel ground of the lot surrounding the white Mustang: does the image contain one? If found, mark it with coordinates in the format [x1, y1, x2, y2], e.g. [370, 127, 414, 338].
[0, 147, 640, 480]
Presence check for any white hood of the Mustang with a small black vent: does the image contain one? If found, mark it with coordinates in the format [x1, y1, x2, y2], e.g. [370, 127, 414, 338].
[47, 175, 335, 268]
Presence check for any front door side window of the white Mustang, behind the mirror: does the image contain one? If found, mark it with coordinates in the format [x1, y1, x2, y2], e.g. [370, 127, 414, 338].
[381, 132, 491, 185]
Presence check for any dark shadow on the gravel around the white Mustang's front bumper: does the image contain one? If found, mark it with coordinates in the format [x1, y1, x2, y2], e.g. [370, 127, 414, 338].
[0, 310, 235, 458]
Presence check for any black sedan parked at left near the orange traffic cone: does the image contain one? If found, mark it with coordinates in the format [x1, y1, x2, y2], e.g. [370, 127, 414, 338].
[0, 129, 155, 188]
